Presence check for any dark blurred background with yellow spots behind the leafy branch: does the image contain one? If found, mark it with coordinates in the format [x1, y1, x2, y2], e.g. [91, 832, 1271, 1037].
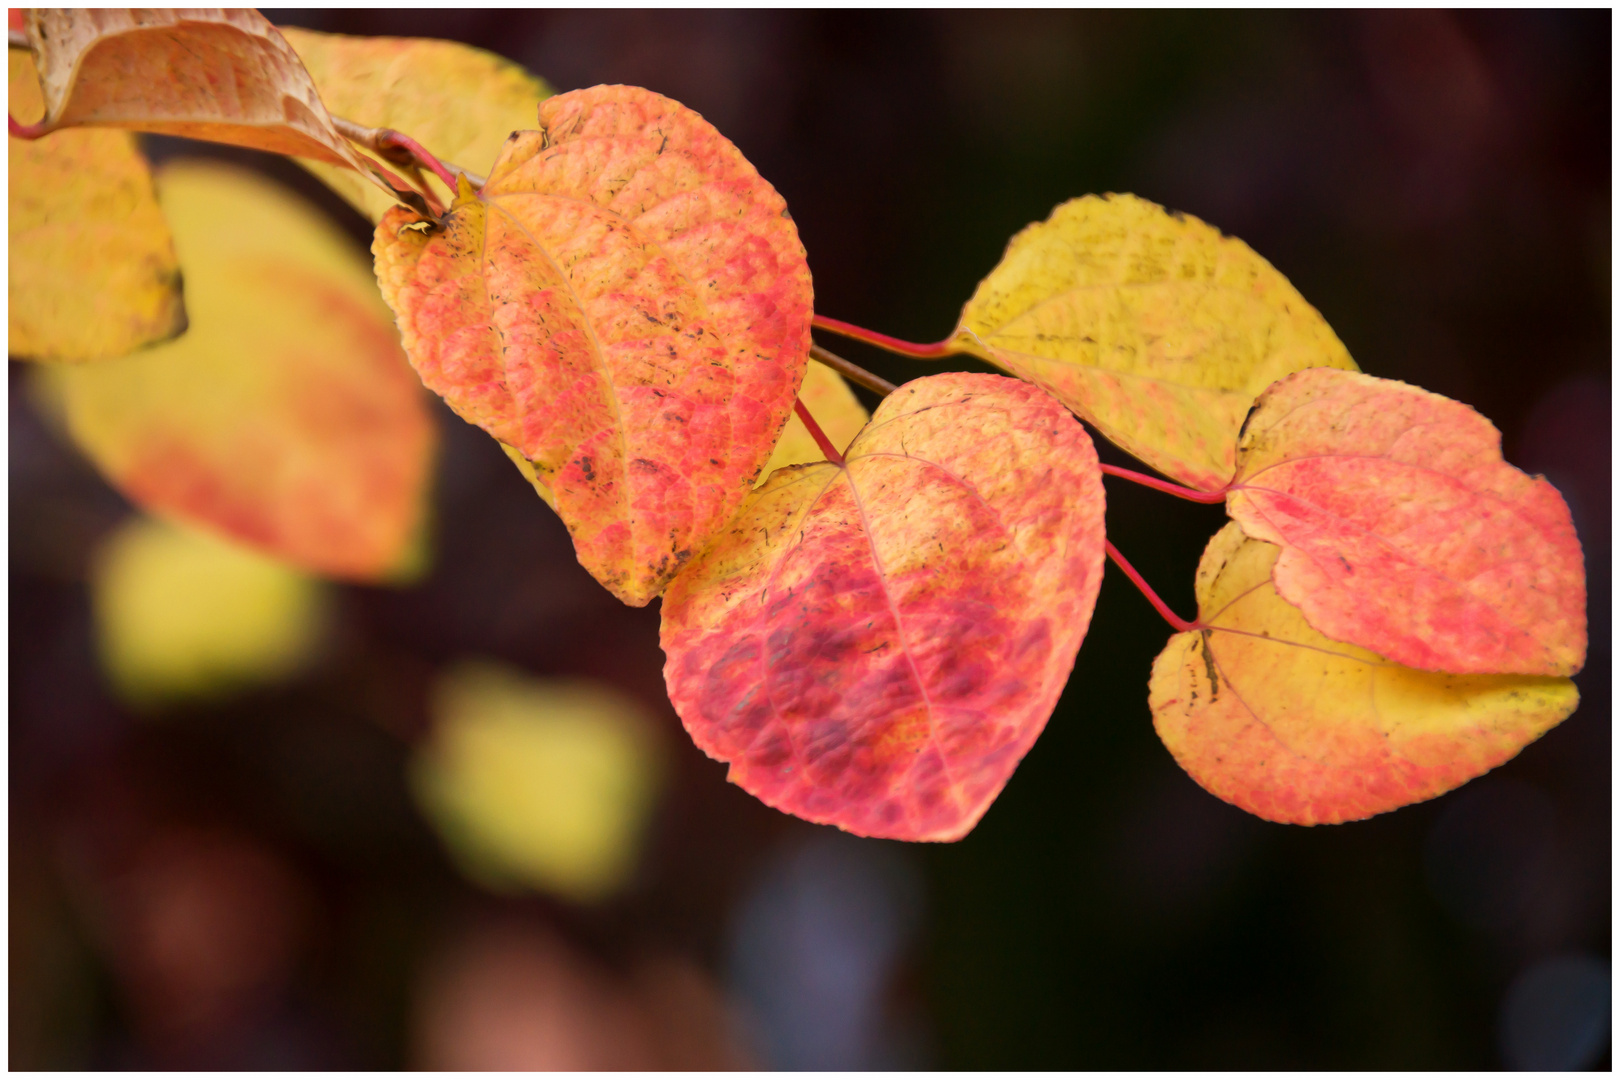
[10, 10, 1612, 1069]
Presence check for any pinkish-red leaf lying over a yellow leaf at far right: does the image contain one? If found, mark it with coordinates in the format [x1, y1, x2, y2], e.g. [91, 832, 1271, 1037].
[1226, 371, 1586, 675]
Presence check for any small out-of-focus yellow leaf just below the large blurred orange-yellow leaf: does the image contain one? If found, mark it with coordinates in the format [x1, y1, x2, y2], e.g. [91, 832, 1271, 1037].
[91, 517, 326, 703]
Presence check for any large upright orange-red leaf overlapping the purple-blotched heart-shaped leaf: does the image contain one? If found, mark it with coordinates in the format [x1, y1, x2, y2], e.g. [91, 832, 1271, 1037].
[373, 86, 812, 606]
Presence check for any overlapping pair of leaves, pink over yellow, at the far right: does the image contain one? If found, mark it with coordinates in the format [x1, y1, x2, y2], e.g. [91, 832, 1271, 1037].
[1150, 369, 1586, 824]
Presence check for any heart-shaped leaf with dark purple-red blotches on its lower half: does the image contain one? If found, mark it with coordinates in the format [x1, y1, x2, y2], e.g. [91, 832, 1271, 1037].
[661, 374, 1103, 840]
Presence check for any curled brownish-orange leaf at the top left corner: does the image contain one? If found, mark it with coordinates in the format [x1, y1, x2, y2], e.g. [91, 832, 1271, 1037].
[24, 8, 401, 198]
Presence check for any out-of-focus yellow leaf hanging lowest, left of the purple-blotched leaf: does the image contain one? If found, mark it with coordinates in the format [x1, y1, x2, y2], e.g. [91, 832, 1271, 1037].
[411, 661, 659, 902]
